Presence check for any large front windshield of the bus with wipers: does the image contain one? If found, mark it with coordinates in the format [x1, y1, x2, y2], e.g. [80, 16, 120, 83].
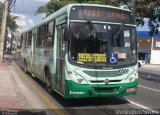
[69, 22, 137, 66]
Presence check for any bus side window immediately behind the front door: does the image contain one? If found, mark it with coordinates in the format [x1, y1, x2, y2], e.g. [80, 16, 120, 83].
[45, 21, 55, 48]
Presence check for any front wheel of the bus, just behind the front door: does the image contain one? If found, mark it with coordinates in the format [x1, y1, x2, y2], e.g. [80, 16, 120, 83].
[45, 70, 52, 93]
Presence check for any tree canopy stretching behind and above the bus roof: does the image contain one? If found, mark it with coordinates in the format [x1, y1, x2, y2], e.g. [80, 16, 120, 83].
[36, 0, 160, 36]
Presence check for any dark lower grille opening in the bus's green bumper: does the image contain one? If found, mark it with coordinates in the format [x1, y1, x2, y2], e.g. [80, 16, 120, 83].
[94, 87, 118, 93]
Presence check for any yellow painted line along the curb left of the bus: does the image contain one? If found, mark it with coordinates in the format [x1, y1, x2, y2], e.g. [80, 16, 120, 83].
[14, 63, 64, 115]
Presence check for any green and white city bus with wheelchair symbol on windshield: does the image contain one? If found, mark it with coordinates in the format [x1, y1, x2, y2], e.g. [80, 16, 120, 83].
[21, 4, 138, 99]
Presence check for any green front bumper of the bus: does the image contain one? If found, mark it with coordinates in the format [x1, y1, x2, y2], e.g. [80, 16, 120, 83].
[65, 79, 138, 98]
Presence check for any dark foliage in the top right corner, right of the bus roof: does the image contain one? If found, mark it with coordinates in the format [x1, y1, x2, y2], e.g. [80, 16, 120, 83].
[121, 0, 160, 36]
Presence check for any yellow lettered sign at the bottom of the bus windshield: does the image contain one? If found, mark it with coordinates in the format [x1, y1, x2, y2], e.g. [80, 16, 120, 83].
[77, 53, 107, 63]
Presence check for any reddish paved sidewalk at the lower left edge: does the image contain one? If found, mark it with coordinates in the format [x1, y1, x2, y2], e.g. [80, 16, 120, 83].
[0, 62, 28, 114]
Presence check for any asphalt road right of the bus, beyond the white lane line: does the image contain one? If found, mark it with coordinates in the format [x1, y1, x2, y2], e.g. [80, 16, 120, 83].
[126, 68, 160, 110]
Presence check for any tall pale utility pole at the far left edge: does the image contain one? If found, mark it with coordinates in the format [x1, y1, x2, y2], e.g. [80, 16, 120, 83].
[0, 0, 8, 62]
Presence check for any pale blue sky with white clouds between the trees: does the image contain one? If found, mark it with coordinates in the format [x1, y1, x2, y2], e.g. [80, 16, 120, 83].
[0, 0, 149, 32]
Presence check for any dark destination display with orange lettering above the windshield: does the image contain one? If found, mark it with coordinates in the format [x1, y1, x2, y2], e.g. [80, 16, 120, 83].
[70, 6, 135, 24]
